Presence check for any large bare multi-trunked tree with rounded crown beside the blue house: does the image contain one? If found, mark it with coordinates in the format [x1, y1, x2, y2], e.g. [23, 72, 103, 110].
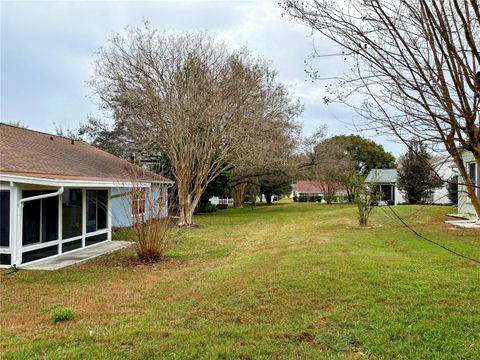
[90, 24, 298, 225]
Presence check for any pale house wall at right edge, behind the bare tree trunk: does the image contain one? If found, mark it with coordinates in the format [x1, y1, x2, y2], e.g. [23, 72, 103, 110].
[458, 151, 480, 218]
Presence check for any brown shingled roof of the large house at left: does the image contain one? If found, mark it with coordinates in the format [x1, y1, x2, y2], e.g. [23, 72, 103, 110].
[0, 123, 169, 186]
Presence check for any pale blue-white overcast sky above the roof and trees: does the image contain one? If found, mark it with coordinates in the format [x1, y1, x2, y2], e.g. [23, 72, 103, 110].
[0, 0, 403, 155]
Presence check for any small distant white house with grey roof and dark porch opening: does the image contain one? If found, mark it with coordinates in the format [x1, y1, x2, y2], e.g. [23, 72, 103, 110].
[365, 169, 406, 205]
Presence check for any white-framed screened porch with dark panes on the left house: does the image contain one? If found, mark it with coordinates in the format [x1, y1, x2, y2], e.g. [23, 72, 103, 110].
[0, 185, 111, 266]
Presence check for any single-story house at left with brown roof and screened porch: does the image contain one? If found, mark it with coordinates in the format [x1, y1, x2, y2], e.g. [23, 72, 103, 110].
[0, 124, 171, 267]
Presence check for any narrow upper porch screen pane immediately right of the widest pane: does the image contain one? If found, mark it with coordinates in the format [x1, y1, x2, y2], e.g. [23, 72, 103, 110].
[62, 189, 82, 239]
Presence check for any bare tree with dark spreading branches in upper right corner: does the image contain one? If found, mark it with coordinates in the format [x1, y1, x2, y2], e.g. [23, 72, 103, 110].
[283, 0, 480, 214]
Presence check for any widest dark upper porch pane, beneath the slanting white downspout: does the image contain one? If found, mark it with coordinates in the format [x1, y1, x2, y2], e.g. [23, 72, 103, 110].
[22, 191, 58, 245]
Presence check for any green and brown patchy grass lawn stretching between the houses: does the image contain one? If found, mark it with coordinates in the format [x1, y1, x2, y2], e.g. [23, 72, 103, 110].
[0, 203, 480, 359]
